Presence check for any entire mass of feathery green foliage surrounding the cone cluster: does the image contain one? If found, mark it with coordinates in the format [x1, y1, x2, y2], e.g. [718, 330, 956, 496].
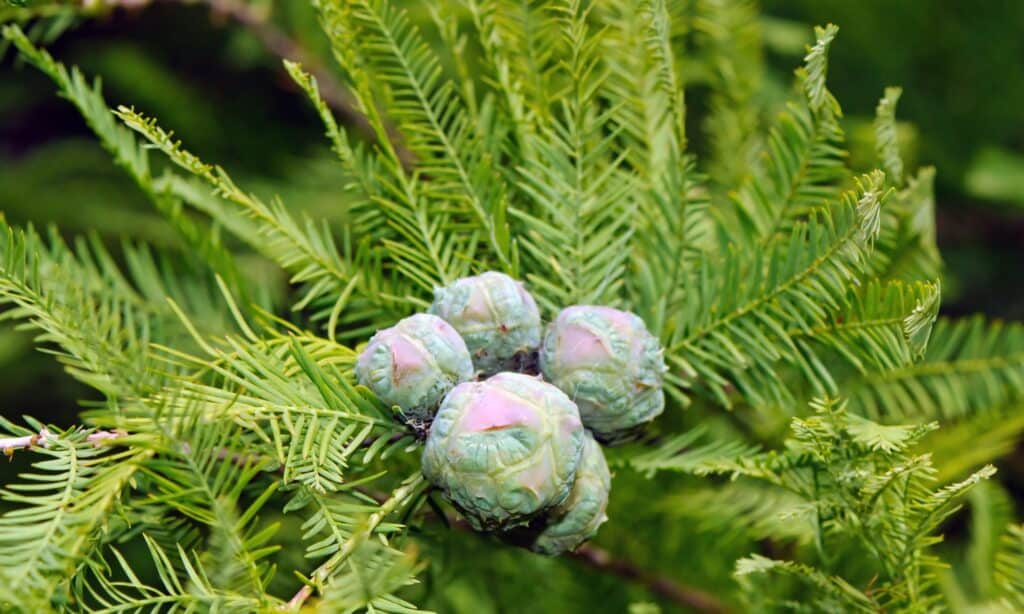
[0, 0, 1024, 612]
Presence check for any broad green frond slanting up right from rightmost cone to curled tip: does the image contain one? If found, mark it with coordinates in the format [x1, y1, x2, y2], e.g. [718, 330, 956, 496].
[667, 172, 887, 406]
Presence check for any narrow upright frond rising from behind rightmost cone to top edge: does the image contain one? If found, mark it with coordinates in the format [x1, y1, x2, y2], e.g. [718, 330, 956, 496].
[596, 2, 712, 334]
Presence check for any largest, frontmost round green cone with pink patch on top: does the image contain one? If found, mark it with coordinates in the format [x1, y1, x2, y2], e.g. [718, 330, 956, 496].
[423, 374, 584, 530]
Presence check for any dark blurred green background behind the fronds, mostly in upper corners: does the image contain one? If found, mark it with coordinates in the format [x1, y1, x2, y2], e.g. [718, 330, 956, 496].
[0, 0, 1024, 422]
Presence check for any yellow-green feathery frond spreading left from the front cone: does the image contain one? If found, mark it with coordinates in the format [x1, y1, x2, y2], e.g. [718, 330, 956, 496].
[153, 329, 412, 492]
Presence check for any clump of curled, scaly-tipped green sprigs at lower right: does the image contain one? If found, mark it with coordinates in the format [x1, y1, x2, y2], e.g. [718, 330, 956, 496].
[642, 400, 995, 612]
